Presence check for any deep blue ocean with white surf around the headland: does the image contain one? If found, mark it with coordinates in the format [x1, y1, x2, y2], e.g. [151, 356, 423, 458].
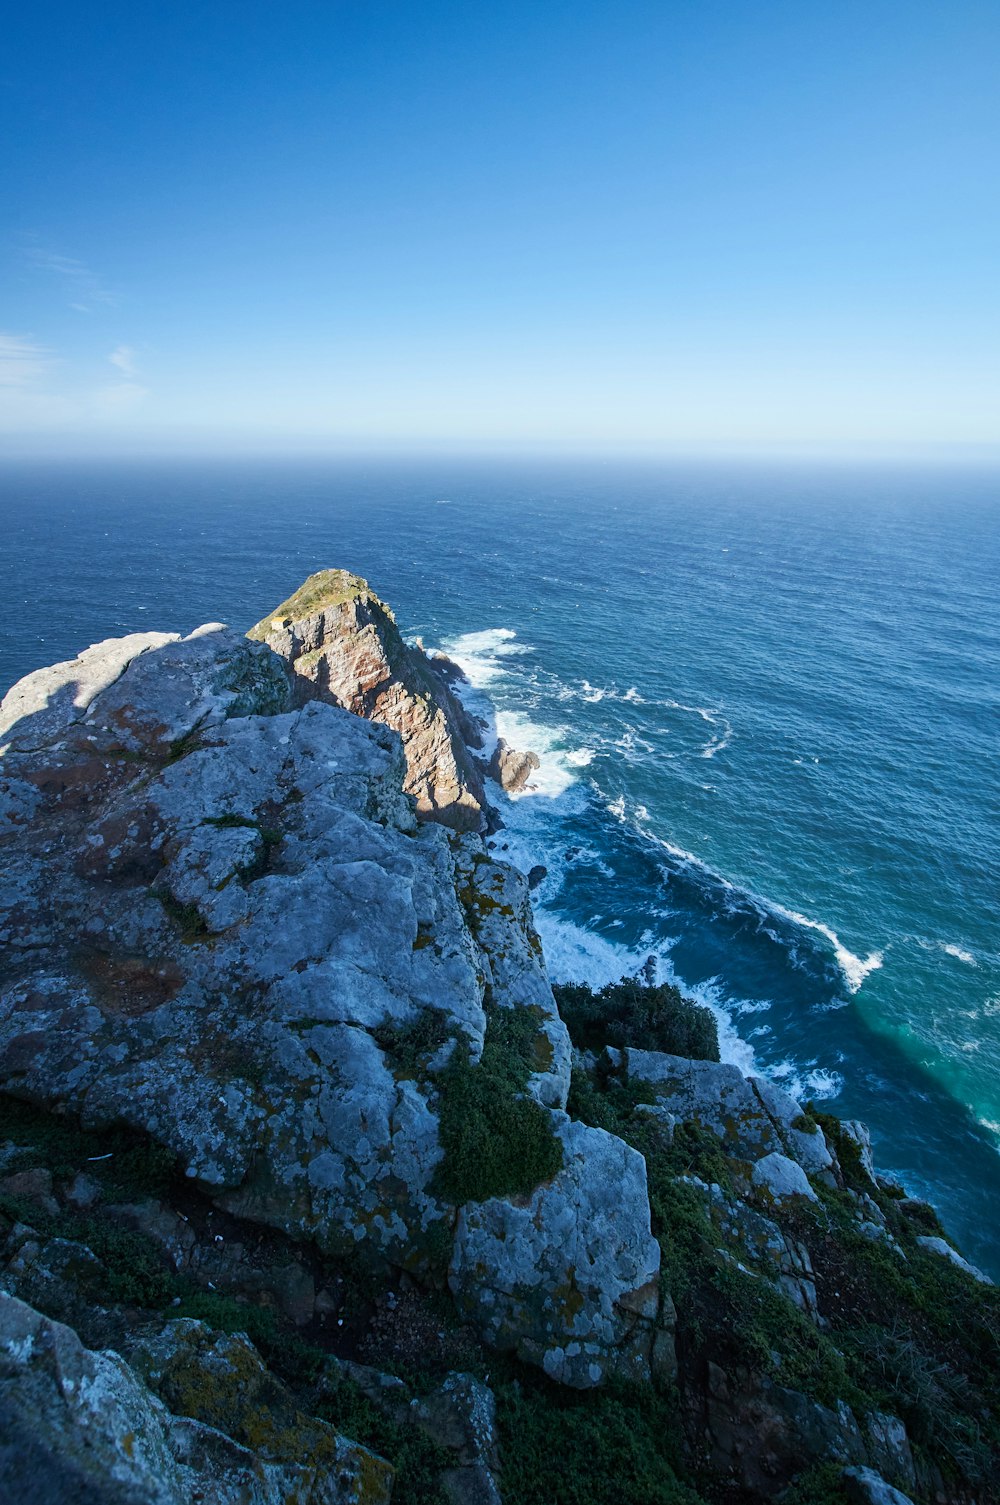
[0, 459, 1000, 1275]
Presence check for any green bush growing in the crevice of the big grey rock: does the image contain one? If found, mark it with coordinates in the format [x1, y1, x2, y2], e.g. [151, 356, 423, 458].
[434, 1007, 563, 1206]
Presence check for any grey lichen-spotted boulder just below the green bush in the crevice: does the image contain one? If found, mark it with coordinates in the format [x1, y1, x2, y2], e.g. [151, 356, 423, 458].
[450, 1115, 660, 1389]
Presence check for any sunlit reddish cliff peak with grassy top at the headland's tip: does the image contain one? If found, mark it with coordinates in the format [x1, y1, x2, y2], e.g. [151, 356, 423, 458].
[248, 569, 492, 831]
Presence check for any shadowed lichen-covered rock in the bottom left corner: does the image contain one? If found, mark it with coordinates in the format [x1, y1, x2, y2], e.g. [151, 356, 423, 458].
[0, 1293, 392, 1505]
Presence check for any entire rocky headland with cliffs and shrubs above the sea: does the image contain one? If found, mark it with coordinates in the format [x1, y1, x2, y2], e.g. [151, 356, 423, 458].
[0, 570, 1000, 1505]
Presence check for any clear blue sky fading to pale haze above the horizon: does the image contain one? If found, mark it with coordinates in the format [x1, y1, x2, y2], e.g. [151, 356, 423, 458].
[0, 0, 1000, 453]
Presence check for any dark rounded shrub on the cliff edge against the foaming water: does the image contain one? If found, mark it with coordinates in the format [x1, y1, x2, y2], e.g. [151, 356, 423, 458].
[553, 978, 718, 1061]
